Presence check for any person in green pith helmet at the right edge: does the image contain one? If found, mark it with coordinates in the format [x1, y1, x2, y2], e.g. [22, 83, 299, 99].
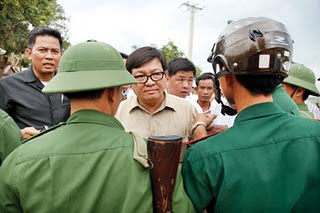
[282, 63, 320, 119]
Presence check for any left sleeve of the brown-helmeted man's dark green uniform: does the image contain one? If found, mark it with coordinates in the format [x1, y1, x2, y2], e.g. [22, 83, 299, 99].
[182, 147, 223, 212]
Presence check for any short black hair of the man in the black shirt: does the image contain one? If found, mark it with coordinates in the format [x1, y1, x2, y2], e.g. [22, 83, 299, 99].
[27, 26, 63, 51]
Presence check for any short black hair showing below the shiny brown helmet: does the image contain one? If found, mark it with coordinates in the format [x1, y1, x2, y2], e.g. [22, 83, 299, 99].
[235, 75, 283, 96]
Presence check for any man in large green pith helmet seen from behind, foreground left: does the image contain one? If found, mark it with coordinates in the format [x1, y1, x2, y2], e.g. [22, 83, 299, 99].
[0, 40, 194, 213]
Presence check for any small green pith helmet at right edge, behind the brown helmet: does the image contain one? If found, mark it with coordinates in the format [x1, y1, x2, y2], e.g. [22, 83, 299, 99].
[283, 64, 320, 96]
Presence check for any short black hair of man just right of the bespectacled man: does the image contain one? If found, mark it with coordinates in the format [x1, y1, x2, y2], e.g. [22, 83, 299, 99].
[168, 58, 196, 77]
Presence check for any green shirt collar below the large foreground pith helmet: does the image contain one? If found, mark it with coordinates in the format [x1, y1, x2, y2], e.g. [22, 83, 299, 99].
[67, 110, 124, 130]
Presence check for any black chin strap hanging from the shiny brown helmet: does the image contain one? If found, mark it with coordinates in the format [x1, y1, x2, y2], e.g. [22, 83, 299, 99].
[212, 60, 237, 116]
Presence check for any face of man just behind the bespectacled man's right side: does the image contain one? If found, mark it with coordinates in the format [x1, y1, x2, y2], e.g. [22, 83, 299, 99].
[168, 71, 194, 98]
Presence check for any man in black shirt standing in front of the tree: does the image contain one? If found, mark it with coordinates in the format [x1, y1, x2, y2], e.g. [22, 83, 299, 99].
[0, 27, 70, 133]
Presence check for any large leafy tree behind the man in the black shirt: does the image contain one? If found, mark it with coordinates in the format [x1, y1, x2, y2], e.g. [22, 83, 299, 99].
[0, 0, 70, 72]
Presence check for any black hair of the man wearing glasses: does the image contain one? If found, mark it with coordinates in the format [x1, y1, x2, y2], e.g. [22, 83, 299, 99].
[126, 46, 168, 73]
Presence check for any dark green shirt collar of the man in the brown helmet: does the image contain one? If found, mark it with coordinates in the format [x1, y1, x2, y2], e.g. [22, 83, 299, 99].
[234, 102, 286, 124]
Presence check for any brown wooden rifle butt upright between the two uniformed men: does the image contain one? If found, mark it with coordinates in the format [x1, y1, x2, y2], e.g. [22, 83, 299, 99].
[147, 135, 182, 213]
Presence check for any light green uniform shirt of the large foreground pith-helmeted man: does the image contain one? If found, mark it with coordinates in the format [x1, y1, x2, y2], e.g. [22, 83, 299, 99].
[0, 110, 194, 213]
